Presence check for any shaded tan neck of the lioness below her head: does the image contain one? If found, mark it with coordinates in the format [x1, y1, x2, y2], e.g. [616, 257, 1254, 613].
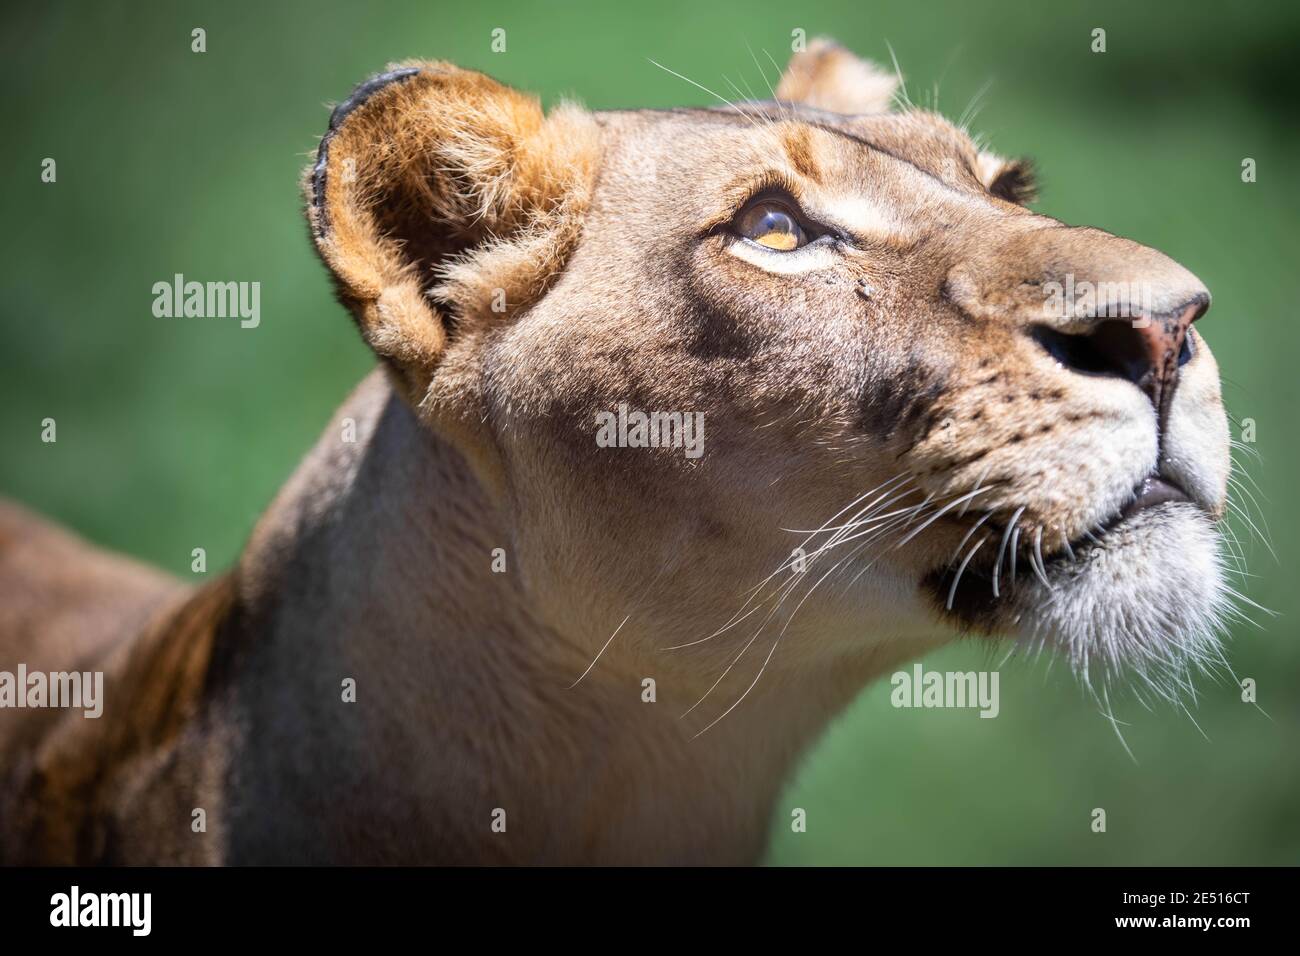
[231, 376, 871, 862]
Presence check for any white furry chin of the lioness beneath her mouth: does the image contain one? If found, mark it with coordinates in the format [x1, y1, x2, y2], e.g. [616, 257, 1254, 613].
[1017, 503, 1229, 697]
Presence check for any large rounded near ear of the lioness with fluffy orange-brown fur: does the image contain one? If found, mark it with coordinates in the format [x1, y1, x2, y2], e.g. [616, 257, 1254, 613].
[306, 62, 597, 401]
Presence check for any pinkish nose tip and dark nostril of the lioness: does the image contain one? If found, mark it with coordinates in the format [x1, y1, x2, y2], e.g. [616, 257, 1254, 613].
[1036, 293, 1210, 424]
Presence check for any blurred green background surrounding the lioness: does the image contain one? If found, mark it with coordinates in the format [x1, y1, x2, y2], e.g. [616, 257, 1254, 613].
[0, 0, 1300, 864]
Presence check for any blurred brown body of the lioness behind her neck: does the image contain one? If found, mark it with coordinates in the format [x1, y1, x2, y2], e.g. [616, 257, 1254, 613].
[0, 506, 234, 864]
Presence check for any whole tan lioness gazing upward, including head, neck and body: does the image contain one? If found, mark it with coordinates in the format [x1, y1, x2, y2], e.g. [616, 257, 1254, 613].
[0, 42, 1229, 864]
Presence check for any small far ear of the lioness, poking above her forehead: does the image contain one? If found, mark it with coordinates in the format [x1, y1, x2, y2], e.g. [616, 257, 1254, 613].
[776, 36, 898, 114]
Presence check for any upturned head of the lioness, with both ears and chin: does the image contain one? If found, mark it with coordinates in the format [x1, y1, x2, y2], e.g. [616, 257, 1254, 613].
[307, 43, 1229, 723]
